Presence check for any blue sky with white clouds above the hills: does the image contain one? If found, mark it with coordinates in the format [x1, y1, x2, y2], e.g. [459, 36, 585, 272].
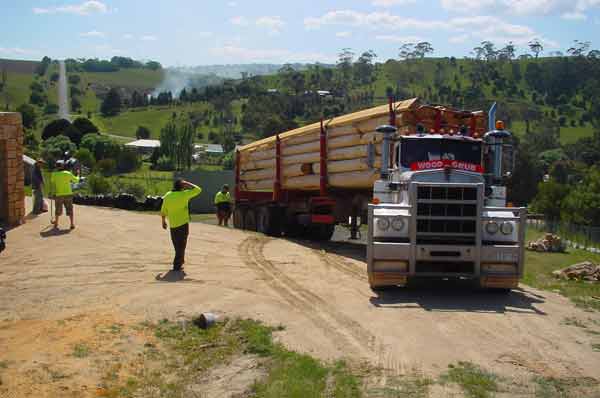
[0, 0, 600, 66]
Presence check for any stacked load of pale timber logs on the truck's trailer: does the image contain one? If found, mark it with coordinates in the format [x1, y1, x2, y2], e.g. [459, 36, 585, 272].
[238, 98, 485, 191]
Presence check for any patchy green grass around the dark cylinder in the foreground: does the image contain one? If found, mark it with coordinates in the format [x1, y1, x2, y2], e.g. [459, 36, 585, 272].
[104, 320, 362, 398]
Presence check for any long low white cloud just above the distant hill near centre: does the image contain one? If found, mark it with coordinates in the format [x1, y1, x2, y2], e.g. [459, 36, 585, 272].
[210, 45, 336, 63]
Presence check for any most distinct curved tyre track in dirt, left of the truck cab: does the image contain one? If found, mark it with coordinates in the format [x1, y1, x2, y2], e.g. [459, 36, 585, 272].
[238, 236, 375, 353]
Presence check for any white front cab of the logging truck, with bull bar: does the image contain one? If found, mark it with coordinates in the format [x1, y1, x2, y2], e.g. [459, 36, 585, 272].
[367, 123, 526, 290]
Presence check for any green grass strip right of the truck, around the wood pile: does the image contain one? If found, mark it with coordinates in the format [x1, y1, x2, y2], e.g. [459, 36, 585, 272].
[523, 228, 600, 310]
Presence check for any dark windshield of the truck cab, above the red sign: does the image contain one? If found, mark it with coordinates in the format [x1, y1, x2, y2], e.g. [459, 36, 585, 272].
[400, 138, 481, 167]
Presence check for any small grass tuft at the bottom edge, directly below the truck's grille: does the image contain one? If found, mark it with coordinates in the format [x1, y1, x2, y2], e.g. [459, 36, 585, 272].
[441, 361, 498, 398]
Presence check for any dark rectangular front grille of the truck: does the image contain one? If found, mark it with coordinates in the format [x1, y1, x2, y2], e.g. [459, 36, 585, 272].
[417, 185, 478, 244]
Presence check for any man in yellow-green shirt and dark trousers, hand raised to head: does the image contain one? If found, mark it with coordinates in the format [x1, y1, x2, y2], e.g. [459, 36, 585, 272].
[160, 180, 202, 271]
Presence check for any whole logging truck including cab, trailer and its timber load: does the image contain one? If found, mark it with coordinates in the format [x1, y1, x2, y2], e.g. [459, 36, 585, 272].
[234, 98, 526, 290]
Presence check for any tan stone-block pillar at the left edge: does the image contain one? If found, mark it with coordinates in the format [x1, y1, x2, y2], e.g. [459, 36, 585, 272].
[0, 112, 25, 227]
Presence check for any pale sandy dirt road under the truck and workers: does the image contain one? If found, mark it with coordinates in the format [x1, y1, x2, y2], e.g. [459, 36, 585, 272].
[0, 202, 600, 394]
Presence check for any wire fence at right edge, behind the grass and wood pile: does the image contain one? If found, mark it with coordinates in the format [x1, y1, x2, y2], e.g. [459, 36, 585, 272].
[527, 218, 600, 253]
